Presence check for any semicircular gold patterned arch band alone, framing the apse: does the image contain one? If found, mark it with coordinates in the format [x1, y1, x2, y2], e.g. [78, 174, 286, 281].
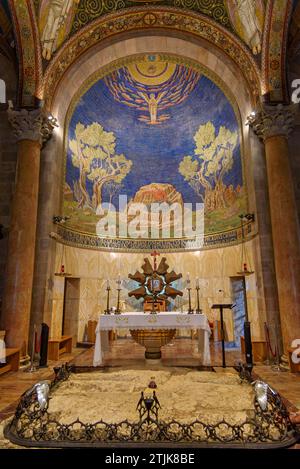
[43, 7, 261, 110]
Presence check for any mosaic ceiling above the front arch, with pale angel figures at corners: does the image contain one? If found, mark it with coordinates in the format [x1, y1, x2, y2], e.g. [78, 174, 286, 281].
[36, 0, 265, 60]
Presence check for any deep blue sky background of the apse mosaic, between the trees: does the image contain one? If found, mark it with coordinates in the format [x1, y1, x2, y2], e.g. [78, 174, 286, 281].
[66, 69, 243, 206]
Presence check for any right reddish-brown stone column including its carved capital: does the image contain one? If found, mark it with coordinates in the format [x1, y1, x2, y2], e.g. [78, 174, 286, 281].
[249, 105, 300, 353]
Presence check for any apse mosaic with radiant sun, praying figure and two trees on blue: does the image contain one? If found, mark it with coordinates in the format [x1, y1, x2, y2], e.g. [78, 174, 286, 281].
[63, 54, 247, 237]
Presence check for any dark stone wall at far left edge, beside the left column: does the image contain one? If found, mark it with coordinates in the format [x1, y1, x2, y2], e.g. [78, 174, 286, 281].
[0, 54, 17, 310]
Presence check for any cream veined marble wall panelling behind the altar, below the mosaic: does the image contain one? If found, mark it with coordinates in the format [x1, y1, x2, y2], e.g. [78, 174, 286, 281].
[51, 240, 265, 340]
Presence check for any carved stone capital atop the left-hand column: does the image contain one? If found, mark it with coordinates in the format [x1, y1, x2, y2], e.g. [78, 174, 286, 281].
[7, 107, 57, 145]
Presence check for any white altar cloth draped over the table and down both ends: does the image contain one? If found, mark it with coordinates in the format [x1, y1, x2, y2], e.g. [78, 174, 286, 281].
[93, 312, 211, 366]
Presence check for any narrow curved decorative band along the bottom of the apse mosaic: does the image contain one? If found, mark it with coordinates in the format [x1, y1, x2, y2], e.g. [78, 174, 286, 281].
[52, 222, 256, 252]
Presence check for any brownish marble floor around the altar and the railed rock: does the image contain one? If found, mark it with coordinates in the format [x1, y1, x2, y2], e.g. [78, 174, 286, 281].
[0, 338, 300, 421]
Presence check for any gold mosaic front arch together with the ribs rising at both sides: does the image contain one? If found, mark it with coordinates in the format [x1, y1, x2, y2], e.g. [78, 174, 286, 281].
[9, 0, 293, 107]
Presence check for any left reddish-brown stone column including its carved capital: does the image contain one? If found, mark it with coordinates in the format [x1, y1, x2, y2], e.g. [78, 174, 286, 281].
[1, 109, 55, 356]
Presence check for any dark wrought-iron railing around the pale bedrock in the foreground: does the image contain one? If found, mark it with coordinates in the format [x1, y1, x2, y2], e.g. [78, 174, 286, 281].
[4, 365, 299, 448]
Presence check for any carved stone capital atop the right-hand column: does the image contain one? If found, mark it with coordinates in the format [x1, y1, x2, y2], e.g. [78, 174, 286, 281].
[247, 104, 297, 141]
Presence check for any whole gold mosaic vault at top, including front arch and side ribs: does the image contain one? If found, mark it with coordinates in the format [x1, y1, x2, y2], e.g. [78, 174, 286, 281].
[6, 0, 295, 106]
